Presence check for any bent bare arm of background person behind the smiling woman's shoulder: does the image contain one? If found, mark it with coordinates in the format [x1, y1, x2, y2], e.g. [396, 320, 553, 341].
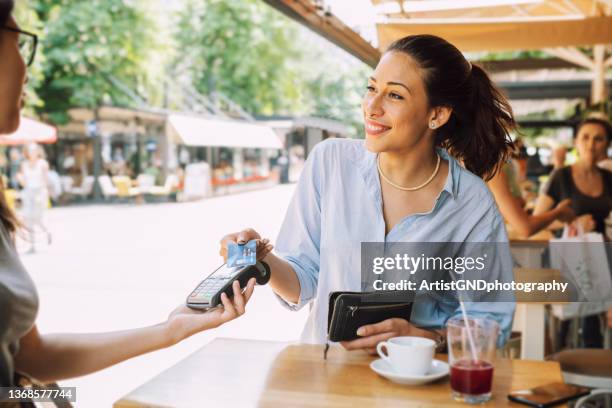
[488, 171, 574, 237]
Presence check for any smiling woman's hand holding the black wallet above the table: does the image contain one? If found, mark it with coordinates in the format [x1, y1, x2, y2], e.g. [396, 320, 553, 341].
[340, 318, 432, 354]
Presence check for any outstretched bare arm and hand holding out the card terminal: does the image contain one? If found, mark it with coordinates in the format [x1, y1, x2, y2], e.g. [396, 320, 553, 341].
[15, 279, 255, 382]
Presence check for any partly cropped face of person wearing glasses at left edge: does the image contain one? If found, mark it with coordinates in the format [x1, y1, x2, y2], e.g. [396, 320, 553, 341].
[0, 17, 26, 135]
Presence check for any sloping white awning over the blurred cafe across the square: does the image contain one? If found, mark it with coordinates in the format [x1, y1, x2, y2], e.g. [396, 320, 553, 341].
[168, 115, 283, 149]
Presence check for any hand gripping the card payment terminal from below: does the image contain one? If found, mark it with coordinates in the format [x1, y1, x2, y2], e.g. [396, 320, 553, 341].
[165, 278, 255, 344]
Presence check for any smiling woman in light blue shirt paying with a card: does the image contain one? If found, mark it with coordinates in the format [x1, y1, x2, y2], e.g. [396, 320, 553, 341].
[221, 35, 515, 352]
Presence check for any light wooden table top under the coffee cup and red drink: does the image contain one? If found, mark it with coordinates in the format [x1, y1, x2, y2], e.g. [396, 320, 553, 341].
[114, 339, 562, 408]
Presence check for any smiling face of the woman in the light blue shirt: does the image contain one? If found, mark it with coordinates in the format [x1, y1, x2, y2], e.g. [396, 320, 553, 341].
[361, 52, 431, 153]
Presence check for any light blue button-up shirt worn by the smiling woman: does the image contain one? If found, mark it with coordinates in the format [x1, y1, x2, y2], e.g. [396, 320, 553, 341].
[275, 139, 514, 345]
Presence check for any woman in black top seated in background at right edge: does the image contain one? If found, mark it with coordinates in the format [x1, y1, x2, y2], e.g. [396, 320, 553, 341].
[534, 118, 612, 347]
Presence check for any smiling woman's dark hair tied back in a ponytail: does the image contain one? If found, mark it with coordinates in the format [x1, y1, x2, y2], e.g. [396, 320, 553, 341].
[387, 35, 516, 180]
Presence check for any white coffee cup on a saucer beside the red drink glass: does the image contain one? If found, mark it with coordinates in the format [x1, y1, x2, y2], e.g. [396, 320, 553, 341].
[376, 336, 436, 375]
